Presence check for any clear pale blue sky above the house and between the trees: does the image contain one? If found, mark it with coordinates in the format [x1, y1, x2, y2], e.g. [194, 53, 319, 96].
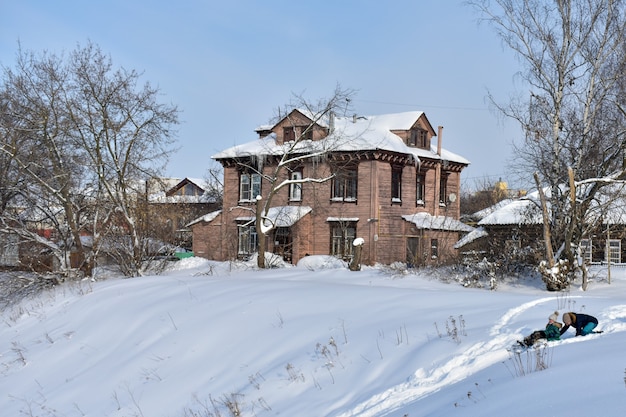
[0, 0, 520, 191]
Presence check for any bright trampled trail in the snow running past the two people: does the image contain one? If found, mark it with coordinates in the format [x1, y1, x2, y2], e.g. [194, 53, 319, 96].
[337, 297, 556, 417]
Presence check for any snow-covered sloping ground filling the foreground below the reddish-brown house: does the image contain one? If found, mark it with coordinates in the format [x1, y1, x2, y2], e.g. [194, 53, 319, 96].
[0, 257, 626, 417]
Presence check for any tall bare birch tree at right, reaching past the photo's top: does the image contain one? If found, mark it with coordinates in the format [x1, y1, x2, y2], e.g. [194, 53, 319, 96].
[468, 0, 626, 289]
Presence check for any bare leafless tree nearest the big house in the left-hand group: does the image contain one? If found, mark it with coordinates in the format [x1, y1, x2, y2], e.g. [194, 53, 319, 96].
[68, 44, 178, 276]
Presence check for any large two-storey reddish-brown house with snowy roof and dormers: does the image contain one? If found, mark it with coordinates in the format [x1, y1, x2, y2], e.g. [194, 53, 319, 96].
[190, 110, 473, 264]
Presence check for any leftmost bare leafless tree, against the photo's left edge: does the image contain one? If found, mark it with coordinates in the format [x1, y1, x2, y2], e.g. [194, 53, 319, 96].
[2, 46, 88, 266]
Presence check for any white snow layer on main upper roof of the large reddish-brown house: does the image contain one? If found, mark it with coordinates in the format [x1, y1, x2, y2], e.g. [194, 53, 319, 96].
[212, 111, 470, 165]
